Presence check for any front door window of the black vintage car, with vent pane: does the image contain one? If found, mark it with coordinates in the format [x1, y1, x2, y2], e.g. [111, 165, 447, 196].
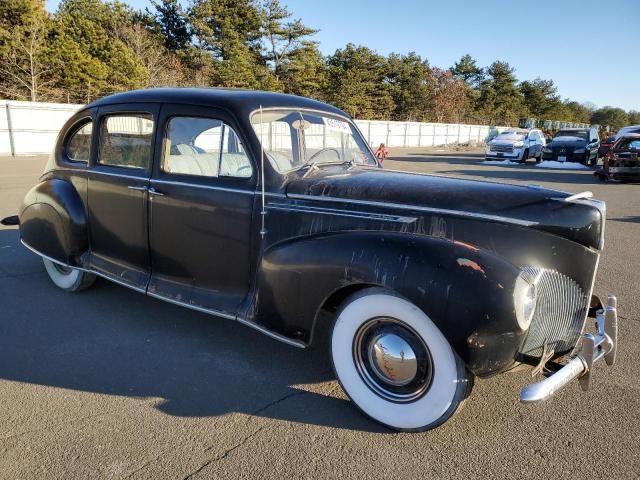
[162, 117, 253, 178]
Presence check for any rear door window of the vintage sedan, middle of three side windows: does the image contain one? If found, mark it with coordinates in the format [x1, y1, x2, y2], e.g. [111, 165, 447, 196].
[98, 113, 153, 169]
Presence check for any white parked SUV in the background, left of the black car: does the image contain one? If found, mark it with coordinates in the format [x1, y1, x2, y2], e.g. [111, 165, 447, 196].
[485, 128, 546, 163]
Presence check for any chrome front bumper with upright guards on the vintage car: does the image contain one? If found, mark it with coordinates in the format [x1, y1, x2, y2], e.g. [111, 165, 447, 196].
[520, 295, 618, 403]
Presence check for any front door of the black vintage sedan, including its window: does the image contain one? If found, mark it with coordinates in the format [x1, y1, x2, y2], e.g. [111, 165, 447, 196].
[148, 105, 257, 317]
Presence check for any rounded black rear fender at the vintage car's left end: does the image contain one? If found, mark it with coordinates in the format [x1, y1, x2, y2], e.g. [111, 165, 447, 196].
[19, 179, 89, 266]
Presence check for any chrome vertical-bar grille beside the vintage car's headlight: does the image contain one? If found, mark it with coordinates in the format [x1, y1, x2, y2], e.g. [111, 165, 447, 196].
[521, 267, 588, 357]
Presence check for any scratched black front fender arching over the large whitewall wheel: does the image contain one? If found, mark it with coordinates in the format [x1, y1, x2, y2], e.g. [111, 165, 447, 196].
[247, 232, 523, 375]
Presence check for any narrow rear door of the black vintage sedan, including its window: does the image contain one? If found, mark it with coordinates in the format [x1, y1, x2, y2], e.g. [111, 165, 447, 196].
[87, 104, 159, 290]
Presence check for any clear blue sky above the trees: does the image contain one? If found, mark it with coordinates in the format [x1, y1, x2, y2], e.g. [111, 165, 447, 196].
[47, 0, 640, 110]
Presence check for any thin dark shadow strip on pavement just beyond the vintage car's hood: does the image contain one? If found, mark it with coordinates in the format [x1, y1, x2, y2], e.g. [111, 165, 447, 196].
[437, 166, 601, 185]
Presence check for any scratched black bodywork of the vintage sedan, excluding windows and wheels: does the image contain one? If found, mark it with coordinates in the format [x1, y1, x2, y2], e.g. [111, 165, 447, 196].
[15, 89, 604, 375]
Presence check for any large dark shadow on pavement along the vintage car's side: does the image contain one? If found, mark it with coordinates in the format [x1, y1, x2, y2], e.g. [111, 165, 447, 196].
[0, 229, 389, 433]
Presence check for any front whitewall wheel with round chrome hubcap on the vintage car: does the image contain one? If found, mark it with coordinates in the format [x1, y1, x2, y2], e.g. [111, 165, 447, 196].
[330, 288, 473, 431]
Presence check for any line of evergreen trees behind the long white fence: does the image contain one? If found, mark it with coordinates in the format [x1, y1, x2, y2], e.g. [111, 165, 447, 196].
[0, 0, 640, 129]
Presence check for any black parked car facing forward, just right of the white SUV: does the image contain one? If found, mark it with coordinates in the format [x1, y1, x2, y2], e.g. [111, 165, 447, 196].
[542, 128, 600, 165]
